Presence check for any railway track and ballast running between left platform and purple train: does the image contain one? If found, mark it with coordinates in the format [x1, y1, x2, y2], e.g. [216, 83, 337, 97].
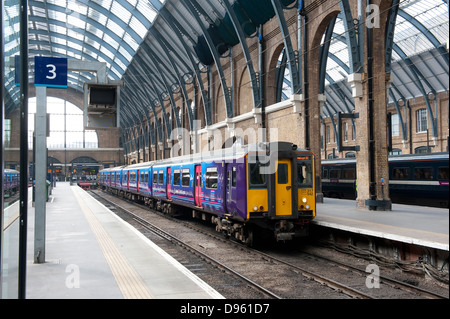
[89, 192, 446, 299]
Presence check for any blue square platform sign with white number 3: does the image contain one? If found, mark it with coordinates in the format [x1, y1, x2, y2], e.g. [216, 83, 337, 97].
[34, 56, 67, 88]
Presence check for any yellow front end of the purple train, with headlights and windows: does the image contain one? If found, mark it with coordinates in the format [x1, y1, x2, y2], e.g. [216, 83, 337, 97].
[247, 142, 316, 241]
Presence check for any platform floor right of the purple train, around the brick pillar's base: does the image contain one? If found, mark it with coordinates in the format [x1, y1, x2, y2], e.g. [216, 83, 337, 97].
[314, 198, 449, 251]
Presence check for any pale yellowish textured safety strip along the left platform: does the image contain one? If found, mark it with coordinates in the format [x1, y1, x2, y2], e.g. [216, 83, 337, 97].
[72, 188, 154, 299]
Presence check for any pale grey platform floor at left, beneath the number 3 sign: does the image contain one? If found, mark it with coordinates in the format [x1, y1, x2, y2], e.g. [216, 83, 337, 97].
[26, 182, 223, 299]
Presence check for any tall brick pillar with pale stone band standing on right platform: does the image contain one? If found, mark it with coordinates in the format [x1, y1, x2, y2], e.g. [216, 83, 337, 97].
[350, 5, 391, 210]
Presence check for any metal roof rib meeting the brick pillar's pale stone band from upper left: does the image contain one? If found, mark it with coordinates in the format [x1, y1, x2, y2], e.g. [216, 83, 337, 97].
[339, 0, 363, 74]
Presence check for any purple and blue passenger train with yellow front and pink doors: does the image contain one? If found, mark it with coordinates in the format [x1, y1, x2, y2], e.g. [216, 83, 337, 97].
[98, 142, 316, 246]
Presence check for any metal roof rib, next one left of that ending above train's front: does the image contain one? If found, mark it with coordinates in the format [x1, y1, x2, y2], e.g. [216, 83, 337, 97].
[183, 0, 234, 118]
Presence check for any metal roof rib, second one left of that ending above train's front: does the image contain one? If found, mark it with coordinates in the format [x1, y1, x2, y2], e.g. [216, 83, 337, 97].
[160, 8, 212, 125]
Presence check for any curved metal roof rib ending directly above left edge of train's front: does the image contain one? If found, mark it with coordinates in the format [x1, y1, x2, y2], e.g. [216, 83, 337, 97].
[223, 0, 262, 108]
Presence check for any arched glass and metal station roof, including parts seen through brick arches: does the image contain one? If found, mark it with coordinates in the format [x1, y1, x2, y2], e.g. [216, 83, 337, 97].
[4, 0, 449, 127]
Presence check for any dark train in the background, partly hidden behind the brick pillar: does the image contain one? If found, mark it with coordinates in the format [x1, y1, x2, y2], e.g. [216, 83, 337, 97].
[321, 153, 449, 208]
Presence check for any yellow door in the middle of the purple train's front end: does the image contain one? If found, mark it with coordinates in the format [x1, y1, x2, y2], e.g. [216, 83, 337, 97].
[275, 159, 292, 216]
